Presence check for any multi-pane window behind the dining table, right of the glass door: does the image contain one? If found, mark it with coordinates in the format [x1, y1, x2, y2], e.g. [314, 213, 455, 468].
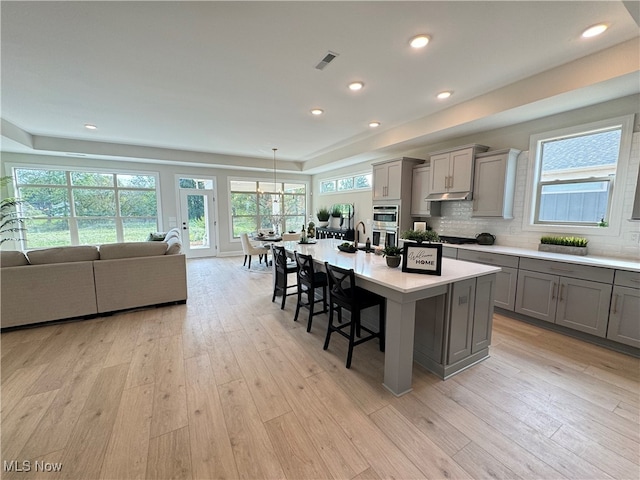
[229, 180, 307, 238]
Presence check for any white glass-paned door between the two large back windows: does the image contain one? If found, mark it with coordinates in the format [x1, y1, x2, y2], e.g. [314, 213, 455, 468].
[179, 188, 218, 258]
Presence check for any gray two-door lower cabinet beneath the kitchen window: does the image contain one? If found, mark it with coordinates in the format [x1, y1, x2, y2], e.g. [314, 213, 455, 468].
[515, 270, 611, 337]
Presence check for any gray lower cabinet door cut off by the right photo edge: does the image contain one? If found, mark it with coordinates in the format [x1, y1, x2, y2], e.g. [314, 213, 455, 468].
[607, 270, 640, 348]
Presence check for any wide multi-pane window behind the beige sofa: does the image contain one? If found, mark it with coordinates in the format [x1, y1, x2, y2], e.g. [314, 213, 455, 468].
[14, 168, 158, 248]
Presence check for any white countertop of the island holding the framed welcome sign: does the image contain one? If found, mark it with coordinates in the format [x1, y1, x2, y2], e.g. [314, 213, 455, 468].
[283, 239, 500, 294]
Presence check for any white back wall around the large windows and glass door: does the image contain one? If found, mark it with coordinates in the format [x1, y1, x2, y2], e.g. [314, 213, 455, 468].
[2, 152, 311, 255]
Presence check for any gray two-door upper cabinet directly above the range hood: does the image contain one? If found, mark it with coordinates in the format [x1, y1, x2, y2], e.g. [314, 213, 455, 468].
[429, 145, 489, 193]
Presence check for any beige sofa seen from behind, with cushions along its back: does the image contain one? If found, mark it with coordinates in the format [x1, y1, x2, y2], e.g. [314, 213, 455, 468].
[0, 229, 187, 329]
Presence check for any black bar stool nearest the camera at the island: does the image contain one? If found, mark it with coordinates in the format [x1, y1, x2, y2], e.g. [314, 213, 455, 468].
[323, 262, 386, 368]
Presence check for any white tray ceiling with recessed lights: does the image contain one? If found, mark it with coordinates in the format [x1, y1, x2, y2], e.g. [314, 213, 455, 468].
[0, 1, 640, 173]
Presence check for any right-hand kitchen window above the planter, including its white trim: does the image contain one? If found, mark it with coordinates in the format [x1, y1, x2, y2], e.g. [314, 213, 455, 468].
[526, 115, 633, 233]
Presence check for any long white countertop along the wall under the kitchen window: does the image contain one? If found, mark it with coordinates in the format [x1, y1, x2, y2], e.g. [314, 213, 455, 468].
[445, 243, 640, 272]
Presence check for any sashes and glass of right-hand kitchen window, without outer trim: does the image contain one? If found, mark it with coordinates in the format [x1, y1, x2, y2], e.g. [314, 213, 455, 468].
[533, 125, 622, 226]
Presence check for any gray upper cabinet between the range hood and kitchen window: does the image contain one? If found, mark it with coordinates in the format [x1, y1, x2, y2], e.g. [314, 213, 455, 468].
[472, 148, 520, 218]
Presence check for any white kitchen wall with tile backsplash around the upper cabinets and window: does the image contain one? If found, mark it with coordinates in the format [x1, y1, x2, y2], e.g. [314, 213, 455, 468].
[313, 95, 640, 260]
